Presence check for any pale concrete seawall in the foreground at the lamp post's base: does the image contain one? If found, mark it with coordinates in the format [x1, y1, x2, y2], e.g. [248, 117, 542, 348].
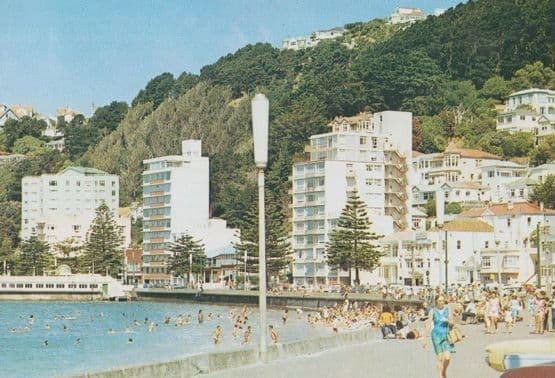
[77, 329, 378, 378]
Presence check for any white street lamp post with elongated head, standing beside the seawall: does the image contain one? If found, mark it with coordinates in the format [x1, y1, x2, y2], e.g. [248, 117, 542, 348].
[252, 93, 270, 360]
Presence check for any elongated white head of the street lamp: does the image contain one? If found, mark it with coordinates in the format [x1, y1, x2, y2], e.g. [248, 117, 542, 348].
[251, 93, 270, 168]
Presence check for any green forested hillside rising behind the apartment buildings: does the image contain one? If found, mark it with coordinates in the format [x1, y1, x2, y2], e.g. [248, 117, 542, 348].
[0, 0, 555, 254]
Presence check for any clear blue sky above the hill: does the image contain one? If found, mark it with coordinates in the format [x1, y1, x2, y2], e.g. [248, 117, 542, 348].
[0, 0, 459, 115]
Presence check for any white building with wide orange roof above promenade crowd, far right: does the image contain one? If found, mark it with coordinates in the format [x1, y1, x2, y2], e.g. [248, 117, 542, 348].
[460, 201, 555, 283]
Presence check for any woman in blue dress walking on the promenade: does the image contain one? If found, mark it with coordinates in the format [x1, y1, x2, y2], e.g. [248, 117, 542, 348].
[423, 295, 454, 378]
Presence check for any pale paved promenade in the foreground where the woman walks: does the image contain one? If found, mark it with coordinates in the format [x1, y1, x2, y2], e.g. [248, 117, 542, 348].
[208, 318, 555, 378]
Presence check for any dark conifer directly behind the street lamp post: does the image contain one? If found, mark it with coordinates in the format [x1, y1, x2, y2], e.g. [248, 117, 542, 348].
[235, 198, 293, 281]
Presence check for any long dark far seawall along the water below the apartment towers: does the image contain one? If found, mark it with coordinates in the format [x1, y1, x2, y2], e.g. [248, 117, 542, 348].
[136, 289, 422, 309]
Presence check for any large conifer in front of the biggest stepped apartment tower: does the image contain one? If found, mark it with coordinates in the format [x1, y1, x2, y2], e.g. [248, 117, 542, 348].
[326, 190, 383, 285]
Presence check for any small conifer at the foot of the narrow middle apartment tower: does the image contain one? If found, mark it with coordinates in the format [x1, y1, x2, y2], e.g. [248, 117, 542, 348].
[168, 234, 206, 282]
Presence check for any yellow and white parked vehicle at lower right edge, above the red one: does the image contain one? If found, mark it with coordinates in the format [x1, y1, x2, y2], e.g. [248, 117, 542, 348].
[486, 337, 555, 371]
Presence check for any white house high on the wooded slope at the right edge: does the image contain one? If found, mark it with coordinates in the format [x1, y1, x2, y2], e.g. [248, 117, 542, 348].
[497, 88, 555, 137]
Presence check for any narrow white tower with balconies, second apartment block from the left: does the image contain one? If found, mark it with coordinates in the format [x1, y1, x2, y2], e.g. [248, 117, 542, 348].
[143, 140, 209, 285]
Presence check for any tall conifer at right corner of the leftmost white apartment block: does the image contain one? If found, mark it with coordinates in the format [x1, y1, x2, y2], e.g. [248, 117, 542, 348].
[82, 202, 123, 277]
